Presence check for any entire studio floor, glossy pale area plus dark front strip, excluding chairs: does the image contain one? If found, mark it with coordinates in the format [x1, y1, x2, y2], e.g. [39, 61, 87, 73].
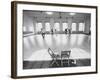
[23, 34, 91, 69]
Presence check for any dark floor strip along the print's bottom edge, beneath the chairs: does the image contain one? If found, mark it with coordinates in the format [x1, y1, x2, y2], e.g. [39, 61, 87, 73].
[23, 59, 91, 69]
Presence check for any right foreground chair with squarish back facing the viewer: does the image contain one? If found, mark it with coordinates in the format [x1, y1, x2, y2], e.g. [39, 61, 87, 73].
[61, 50, 71, 66]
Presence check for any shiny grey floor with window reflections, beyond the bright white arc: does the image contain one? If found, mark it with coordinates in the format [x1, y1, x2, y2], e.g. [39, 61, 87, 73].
[23, 34, 90, 60]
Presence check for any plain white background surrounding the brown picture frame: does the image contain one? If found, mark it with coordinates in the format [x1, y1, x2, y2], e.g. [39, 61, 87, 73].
[0, 0, 100, 80]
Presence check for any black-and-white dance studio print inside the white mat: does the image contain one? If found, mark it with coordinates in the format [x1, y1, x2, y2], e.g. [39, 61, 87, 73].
[23, 10, 91, 69]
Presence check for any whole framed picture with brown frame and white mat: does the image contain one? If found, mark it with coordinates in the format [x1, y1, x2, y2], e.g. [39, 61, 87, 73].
[11, 1, 97, 78]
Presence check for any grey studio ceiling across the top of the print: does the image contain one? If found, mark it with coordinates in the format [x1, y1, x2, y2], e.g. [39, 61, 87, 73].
[23, 10, 90, 18]
